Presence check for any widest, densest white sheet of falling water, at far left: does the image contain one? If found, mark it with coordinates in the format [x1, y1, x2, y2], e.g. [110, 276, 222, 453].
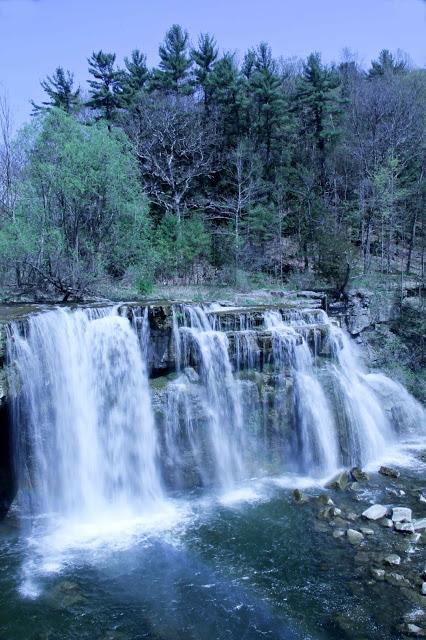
[9, 309, 162, 516]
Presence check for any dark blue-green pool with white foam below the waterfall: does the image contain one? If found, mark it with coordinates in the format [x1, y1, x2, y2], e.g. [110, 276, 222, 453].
[0, 471, 424, 640]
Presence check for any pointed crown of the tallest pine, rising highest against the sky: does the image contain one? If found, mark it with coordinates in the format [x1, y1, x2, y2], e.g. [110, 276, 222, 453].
[153, 24, 193, 95]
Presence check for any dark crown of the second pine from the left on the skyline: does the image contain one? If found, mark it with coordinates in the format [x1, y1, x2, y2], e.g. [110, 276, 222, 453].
[87, 51, 122, 122]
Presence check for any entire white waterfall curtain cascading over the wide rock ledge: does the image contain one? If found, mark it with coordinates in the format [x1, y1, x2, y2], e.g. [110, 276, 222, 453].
[4, 305, 425, 518]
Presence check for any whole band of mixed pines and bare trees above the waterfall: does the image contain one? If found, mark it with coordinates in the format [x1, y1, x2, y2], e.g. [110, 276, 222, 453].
[0, 25, 426, 298]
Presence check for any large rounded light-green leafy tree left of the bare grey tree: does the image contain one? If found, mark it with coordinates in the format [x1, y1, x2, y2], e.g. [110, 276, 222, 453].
[1, 109, 150, 296]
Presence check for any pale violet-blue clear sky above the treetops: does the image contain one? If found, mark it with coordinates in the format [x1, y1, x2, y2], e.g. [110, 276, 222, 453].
[0, 0, 426, 127]
